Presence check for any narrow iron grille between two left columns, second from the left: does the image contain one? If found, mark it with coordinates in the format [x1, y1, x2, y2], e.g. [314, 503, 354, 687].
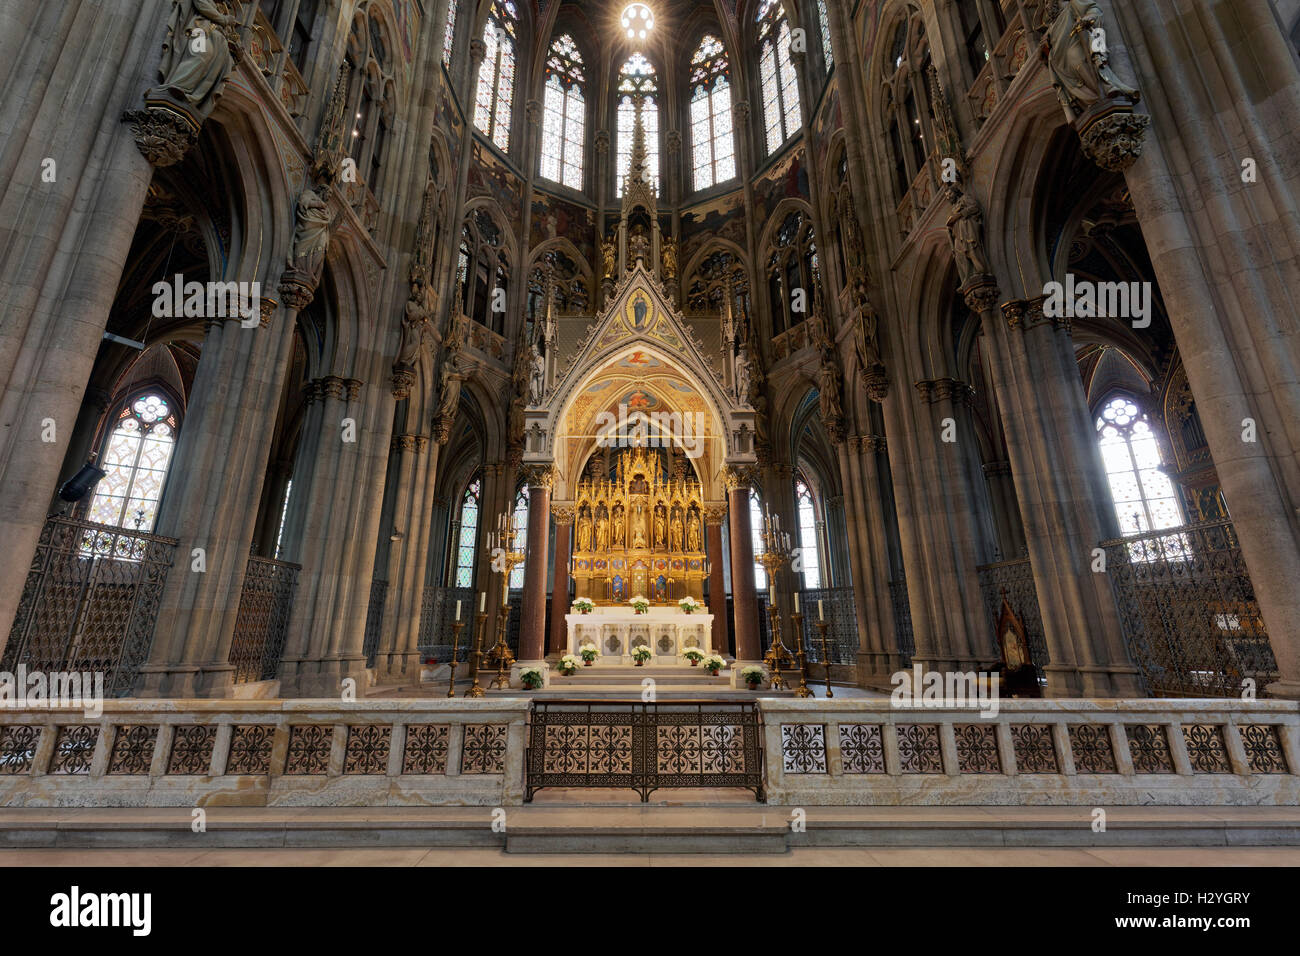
[230, 554, 302, 684]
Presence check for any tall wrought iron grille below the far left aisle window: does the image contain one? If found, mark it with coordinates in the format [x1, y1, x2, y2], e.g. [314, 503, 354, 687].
[0, 516, 177, 697]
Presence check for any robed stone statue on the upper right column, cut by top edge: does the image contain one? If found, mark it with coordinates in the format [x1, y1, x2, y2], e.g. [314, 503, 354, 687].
[1043, 0, 1140, 122]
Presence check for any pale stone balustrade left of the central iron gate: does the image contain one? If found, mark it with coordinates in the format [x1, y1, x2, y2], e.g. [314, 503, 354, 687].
[0, 700, 530, 806]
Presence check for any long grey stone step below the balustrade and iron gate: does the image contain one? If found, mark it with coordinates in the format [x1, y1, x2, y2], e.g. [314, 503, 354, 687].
[0, 806, 1300, 855]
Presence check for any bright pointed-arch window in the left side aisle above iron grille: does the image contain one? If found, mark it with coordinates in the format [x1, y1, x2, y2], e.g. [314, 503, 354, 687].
[87, 392, 177, 531]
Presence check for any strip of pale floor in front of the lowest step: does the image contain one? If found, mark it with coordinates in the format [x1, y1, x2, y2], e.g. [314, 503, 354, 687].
[0, 847, 1300, 868]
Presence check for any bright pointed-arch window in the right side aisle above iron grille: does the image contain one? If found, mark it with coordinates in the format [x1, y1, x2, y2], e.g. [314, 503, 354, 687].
[1097, 395, 1186, 557]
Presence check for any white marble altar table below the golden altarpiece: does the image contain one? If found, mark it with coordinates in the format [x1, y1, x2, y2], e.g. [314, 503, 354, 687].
[564, 606, 714, 666]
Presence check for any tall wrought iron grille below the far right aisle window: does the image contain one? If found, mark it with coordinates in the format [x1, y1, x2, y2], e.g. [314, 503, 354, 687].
[1102, 520, 1274, 697]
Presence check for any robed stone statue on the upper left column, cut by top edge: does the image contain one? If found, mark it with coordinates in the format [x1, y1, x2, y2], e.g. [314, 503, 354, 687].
[159, 0, 235, 114]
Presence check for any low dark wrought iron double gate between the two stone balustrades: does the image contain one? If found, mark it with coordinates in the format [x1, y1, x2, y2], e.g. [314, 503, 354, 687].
[524, 700, 763, 803]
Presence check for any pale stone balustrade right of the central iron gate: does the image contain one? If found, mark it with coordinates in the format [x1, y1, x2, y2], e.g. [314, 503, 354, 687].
[762, 698, 1300, 806]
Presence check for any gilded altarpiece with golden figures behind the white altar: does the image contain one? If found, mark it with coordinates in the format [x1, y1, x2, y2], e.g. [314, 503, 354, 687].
[572, 447, 709, 607]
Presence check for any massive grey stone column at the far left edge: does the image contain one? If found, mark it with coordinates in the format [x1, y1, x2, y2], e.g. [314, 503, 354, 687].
[0, 0, 164, 646]
